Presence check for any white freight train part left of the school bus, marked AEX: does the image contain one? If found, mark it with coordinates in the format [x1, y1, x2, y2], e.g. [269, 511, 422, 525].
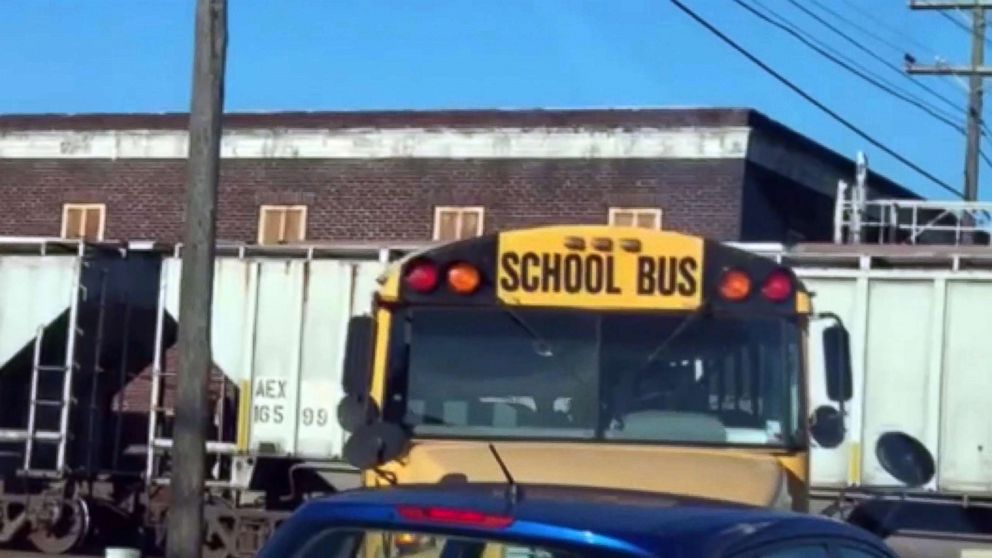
[0, 238, 412, 556]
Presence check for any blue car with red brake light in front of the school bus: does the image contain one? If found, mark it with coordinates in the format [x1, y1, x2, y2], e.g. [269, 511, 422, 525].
[259, 483, 897, 558]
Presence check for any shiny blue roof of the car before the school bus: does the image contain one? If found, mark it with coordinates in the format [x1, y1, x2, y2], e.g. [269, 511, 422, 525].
[266, 483, 892, 555]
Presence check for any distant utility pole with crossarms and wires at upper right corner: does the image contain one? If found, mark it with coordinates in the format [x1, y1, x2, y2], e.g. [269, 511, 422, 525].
[906, 0, 992, 201]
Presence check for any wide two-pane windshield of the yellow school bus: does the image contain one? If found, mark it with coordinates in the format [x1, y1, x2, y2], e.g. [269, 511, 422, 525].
[385, 307, 802, 447]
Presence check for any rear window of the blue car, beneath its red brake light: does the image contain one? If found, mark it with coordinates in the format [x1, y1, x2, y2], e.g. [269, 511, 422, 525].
[291, 528, 582, 558]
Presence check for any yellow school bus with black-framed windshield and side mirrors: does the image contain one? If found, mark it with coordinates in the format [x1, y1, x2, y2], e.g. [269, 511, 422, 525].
[338, 226, 850, 510]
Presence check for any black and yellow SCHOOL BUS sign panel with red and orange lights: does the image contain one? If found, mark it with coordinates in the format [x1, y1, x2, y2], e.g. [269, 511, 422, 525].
[378, 225, 809, 313]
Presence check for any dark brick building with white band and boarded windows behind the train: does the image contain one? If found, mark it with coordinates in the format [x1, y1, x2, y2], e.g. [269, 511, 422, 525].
[0, 109, 916, 243]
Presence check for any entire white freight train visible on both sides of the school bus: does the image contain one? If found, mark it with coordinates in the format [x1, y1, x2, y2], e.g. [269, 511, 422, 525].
[0, 238, 992, 557]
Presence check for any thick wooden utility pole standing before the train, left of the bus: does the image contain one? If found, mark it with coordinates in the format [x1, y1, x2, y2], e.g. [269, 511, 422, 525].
[167, 0, 227, 558]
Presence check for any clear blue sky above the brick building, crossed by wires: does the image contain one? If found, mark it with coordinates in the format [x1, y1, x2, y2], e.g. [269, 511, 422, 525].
[0, 0, 992, 199]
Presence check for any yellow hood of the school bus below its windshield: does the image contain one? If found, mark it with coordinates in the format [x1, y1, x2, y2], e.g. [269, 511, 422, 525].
[382, 441, 785, 506]
